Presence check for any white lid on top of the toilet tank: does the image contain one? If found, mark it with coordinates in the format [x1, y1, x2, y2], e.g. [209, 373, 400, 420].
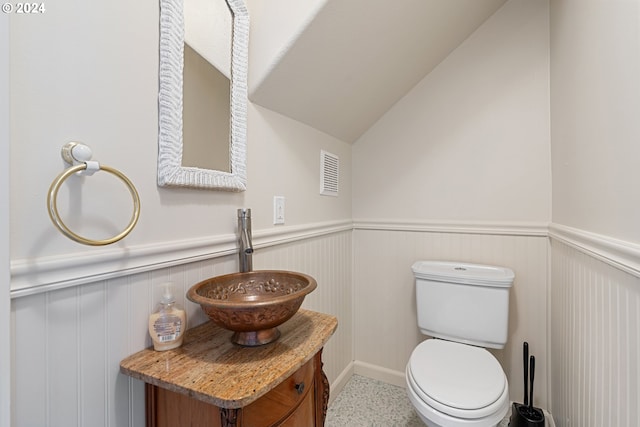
[411, 261, 515, 287]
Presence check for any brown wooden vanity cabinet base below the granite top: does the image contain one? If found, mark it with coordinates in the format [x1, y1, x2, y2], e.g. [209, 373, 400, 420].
[146, 350, 329, 427]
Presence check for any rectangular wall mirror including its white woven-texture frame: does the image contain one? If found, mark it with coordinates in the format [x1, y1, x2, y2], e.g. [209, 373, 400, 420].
[158, 0, 249, 191]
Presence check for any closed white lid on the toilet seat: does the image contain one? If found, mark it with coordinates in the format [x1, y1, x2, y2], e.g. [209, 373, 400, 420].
[409, 339, 507, 412]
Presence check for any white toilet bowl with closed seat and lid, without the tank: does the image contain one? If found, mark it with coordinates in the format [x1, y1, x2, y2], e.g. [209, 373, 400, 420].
[406, 338, 509, 427]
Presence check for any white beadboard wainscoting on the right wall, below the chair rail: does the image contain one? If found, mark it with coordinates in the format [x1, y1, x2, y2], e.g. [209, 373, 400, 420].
[550, 239, 640, 427]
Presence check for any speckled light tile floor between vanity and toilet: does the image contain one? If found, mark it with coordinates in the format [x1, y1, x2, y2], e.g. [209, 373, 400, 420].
[325, 375, 509, 427]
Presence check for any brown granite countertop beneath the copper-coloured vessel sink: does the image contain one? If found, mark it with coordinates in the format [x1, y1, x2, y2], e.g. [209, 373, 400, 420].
[120, 309, 338, 408]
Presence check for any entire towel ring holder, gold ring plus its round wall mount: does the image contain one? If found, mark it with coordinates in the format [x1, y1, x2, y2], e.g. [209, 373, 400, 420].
[47, 142, 140, 246]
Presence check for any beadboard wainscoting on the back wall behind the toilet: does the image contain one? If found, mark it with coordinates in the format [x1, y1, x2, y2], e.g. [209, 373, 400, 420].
[354, 226, 549, 407]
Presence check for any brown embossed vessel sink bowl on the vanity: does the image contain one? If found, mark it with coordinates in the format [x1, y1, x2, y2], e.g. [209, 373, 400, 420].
[187, 270, 317, 346]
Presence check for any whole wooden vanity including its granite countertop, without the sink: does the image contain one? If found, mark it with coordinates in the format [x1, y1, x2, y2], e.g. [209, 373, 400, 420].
[120, 309, 338, 427]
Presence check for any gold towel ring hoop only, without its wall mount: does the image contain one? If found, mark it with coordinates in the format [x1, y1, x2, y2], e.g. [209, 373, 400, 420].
[47, 163, 140, 246]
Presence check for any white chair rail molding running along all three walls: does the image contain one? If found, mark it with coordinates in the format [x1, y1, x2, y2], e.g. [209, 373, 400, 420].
[10, 219, 640, 298]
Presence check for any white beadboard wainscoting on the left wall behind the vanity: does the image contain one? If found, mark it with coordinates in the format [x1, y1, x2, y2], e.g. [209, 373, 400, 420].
[12, 230, 353, 427]
